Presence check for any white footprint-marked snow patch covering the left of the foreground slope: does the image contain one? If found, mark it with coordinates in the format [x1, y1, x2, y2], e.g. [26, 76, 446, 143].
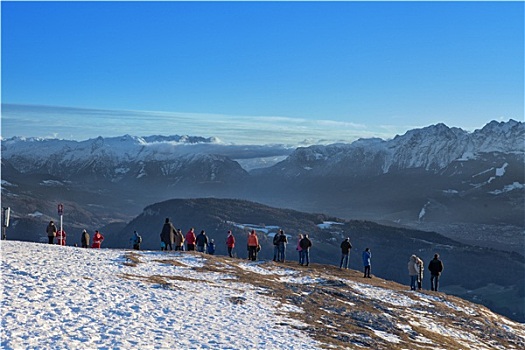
[0, 241, 320, 349]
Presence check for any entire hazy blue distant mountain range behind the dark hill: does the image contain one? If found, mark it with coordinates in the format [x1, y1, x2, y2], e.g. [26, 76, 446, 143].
[2, 120, 525, 232]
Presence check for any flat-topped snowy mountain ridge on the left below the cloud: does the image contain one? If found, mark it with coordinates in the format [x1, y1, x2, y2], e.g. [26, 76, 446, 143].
[2, 135, 250, 182]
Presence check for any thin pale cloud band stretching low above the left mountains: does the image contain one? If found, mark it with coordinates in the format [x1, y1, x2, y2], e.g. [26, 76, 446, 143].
[2, 104, 402, 147]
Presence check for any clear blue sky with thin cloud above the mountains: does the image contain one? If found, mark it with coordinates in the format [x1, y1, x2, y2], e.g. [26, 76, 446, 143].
[1, 2, 524, 143]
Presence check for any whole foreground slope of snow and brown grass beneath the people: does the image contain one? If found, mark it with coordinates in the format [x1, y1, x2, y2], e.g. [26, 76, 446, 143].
[0, 241, 525, 349]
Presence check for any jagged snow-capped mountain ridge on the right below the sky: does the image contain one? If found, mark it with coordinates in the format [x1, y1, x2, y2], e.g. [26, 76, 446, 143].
[263, 120, 525, 177]
